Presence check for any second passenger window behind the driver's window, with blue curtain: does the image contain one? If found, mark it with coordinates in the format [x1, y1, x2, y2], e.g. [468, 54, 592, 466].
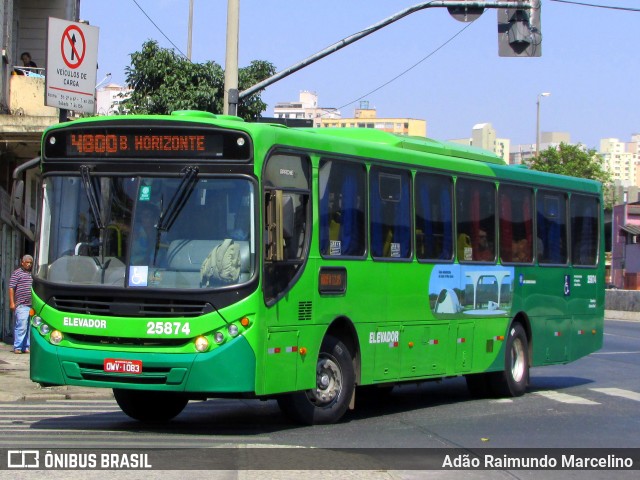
[369, 167, 411, 258]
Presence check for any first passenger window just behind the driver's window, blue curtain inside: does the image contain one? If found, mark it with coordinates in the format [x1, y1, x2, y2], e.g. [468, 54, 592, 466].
[319, 160, 366, 257]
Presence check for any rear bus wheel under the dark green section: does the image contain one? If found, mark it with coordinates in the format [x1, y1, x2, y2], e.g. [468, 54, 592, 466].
[489, 323, 529, 397]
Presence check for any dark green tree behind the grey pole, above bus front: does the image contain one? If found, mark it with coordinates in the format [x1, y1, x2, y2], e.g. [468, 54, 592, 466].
[120, 40, 275, 120]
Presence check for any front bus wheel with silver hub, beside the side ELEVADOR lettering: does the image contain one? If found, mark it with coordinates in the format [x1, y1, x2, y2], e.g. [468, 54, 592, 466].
[278, 335, 355, 425]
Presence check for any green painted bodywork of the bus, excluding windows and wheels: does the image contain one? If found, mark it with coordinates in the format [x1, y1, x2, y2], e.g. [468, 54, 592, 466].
[31, 114, 604, 396]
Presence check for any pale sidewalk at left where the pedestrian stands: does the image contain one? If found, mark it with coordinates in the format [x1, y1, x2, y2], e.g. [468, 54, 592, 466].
[0, 342, 113, 402]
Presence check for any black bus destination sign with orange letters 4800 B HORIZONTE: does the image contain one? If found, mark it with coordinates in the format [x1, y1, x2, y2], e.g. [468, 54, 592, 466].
[44, 128, 249, 160]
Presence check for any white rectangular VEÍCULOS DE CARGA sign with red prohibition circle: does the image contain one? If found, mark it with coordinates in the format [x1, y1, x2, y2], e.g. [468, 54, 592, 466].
[45, 17, 99, 113]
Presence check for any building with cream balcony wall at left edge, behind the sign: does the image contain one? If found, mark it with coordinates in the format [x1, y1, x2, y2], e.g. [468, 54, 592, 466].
[0, 0, 80, 341]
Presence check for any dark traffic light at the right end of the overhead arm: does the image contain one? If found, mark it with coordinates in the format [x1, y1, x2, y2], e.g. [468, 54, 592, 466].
[497, 0, 542, 57]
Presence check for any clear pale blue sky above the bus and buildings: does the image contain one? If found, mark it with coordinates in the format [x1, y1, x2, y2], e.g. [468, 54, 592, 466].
[80, 0, 640, 149]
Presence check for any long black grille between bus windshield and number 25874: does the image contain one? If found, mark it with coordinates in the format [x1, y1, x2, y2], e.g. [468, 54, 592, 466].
[50, 297, 213, 318]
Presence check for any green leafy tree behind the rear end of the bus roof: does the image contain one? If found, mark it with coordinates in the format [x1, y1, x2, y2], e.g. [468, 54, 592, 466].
[529, 143, 612, 209]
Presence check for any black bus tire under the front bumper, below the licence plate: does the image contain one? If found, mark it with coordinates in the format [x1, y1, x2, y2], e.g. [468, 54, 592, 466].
[113, 388, 189, 423]
